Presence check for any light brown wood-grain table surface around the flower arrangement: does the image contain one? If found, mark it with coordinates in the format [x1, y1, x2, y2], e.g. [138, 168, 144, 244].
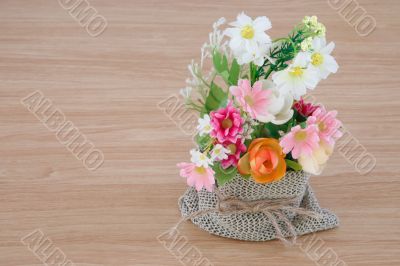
[0, 0, 400, 266]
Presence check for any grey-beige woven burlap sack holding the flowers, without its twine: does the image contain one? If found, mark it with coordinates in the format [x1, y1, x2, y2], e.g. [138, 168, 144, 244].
[179, 171, 339, 241]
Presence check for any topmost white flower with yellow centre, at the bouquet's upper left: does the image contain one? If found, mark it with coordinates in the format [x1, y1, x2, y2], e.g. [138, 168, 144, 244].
[224, 12, 271, 66]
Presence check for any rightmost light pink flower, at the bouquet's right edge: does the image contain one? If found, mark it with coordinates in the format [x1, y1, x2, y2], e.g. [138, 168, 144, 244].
[307, 106, 343, 146]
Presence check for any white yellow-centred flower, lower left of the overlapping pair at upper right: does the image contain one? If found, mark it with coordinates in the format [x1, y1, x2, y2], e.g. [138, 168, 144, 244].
[272, 53, 320, 100]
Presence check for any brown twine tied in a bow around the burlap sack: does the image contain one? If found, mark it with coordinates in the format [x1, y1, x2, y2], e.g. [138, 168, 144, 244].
[172, 188, 321, 245]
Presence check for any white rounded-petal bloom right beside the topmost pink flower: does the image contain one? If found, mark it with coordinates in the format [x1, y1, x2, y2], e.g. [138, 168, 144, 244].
[258, 80, 293, 125]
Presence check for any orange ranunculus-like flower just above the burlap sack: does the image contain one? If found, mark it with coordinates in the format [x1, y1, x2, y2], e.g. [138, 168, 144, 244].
[238, 138, 286, 183]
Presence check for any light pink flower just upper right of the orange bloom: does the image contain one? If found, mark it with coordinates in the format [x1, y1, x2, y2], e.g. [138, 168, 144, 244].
[279, 125, 319, 159]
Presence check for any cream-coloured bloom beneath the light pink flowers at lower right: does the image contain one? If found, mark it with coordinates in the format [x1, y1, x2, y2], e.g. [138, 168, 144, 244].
[298, 143, 333, 175]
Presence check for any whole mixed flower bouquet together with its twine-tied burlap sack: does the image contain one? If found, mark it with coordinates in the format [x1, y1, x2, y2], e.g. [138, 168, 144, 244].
[178, 13, 341, 242]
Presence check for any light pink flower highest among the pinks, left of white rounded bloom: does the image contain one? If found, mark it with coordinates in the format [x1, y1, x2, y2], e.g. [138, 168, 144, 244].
[229, 79, 272, 120]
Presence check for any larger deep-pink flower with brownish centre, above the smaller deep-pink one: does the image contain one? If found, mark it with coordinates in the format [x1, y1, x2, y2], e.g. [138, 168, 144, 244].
[210, 102, 244, 143]
